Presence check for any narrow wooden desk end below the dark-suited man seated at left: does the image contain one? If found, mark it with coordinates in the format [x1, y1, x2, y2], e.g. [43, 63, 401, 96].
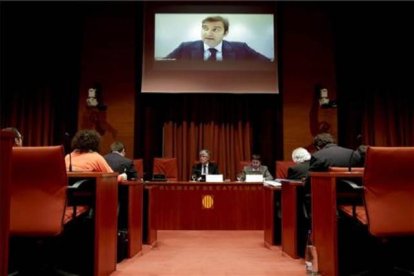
[119, 180, 144, 258]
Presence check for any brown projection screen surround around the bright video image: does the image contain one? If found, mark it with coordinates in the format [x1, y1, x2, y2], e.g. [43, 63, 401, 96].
[141, 1, 280, 94]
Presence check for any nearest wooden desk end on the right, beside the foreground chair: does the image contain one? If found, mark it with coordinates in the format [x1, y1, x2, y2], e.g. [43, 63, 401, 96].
[310, 171, 363, 276]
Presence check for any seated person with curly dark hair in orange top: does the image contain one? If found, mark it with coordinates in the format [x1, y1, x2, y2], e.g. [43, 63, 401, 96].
[65, 129, 125, 181]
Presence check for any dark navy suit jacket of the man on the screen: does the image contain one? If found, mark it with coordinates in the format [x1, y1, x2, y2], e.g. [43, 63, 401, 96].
[166, 40, 270, 61]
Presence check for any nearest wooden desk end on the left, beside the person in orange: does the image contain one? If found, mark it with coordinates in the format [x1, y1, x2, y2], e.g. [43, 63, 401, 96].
[68, 172, 118, 276]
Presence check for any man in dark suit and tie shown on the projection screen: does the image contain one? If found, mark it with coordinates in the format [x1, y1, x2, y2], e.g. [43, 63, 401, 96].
[166, 16, 270, 61]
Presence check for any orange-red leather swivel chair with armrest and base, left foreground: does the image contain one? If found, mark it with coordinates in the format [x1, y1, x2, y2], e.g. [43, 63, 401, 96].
[9, 146, 84, 275]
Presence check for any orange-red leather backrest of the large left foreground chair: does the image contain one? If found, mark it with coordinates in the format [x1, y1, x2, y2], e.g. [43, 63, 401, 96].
[10, 146, 68, 236]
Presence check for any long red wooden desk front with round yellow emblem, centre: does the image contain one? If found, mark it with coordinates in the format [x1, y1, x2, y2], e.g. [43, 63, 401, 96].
[145, 181, 263, 243]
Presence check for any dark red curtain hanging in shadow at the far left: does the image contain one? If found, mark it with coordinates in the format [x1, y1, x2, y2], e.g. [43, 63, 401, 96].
[0, 2, 82, 146]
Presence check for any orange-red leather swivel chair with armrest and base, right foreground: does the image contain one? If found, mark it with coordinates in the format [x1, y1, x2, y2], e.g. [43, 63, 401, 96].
[340, 147, 414, 275]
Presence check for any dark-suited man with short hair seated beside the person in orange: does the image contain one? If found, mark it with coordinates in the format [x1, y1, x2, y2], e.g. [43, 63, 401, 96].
[104, 141, 137, 180]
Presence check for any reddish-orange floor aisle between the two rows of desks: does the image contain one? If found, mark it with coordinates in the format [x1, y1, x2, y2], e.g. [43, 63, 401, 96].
[111, 231, 306, 276]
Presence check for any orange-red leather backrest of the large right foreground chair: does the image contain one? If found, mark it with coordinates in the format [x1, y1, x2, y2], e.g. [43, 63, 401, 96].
[364, 147, 414, 236]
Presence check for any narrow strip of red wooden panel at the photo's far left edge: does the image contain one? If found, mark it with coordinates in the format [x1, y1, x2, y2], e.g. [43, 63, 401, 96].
[0, 131, 14, 276]
